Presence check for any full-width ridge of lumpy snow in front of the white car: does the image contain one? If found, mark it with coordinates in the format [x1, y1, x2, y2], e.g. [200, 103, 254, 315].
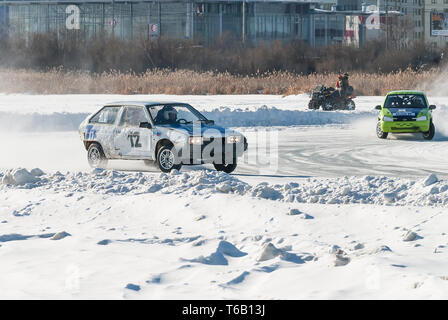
[0, 169, 448, 208]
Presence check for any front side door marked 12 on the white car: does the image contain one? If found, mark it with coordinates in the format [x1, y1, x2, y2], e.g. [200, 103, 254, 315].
[114, 106, 152, 159]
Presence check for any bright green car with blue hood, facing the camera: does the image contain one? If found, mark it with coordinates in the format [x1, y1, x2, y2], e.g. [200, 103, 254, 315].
[375, 91, 436, 140]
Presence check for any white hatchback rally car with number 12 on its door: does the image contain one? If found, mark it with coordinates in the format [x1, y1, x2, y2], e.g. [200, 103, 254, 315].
[79, 102, 247, 173]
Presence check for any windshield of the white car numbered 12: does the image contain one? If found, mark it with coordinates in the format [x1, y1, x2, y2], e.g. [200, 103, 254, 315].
[148, 104, 208, 125]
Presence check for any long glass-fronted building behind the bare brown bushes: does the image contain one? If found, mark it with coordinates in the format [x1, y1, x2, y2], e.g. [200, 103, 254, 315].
[0, 0, 368, 46]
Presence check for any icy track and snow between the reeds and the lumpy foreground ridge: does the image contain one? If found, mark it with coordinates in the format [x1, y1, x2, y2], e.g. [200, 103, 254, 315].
[0, 95, 448, 181]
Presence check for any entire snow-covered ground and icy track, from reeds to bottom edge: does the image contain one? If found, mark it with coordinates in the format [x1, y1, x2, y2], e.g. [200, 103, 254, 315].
[0, 95, 448, 299]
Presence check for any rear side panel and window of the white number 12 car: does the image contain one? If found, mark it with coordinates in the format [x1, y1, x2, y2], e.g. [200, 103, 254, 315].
[84, 106, 121, 157]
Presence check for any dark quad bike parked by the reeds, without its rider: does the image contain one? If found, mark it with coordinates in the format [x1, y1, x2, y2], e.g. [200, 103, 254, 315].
[308, 85, 356, 111]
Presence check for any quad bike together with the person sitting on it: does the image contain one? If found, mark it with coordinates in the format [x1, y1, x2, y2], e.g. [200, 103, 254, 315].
[308, 73, 356, 111]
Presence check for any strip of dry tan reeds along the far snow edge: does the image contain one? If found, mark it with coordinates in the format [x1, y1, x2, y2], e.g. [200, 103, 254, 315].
[0, 69, 440, 95]
